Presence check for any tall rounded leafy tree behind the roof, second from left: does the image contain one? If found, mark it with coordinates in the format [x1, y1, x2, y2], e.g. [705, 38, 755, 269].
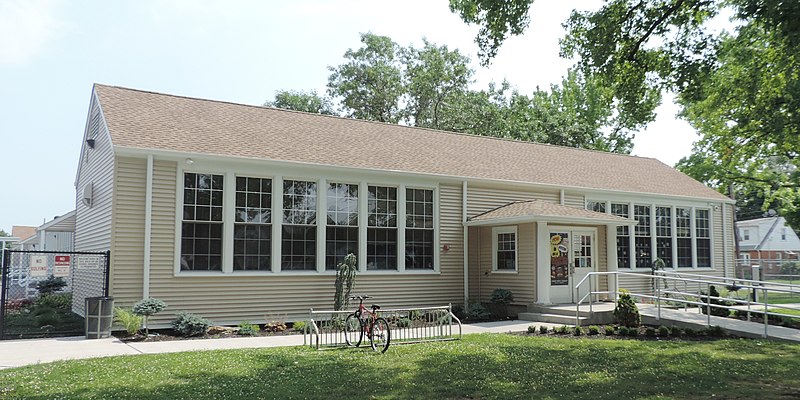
[328, 33, 403, 123]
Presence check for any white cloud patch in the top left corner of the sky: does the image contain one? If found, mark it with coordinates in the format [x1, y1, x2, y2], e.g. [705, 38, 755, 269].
[0, 0, 62, 66]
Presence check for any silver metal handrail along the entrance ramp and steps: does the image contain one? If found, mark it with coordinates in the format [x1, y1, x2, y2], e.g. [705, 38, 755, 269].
[575, 271, 800, 337]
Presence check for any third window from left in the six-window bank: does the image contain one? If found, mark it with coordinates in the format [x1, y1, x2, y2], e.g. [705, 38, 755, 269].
[281, 180, 317, 271]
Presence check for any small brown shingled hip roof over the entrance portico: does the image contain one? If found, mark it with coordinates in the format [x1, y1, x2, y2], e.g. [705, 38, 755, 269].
[464, 200, 636, 226]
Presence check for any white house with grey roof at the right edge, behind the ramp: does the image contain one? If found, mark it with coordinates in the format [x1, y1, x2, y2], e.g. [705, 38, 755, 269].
[736, 216, 800, 274]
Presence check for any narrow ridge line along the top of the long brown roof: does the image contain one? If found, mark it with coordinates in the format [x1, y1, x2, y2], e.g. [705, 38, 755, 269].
[94, 83, 667, 165]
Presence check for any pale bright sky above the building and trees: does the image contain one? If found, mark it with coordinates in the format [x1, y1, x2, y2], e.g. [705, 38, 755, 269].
[0, 0, 698, 232]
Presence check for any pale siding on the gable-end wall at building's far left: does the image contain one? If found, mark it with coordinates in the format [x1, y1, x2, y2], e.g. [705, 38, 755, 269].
[72, 96, 114, 315]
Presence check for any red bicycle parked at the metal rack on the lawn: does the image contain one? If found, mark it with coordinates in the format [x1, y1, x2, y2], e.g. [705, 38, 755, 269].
[344, 295, 391, 353]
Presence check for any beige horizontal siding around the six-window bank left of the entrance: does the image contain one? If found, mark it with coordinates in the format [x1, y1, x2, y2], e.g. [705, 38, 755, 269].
[109, 159, 464, 326]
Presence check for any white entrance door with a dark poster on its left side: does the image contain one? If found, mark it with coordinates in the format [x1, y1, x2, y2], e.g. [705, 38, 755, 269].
[550, 228, 596, 303]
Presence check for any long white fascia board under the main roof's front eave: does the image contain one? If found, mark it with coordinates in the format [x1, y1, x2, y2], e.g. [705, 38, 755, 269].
[114, 146, 736, 204]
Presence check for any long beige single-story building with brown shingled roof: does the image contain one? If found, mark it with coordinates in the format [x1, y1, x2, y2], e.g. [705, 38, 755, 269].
[75, 85, 734, 325]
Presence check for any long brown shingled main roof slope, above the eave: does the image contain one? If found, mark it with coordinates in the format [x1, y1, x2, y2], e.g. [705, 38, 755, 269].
[95, 85, 727, 201]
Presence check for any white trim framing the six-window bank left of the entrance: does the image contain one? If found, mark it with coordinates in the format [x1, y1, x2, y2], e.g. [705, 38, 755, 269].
[173, 158, 444, 277]
